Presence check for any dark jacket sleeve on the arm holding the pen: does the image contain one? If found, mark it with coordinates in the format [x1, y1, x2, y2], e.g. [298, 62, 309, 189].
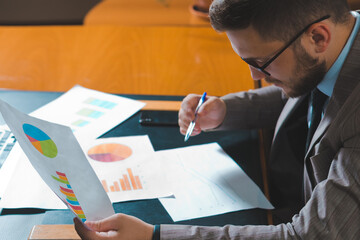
[215, 86, 287, 130]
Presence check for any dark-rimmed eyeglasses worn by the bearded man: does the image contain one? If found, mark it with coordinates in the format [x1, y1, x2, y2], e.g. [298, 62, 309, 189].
[241, 15, 330, 76]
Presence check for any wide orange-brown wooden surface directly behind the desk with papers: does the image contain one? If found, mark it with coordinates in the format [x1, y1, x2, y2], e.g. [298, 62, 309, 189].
[0, 26, 253, 95]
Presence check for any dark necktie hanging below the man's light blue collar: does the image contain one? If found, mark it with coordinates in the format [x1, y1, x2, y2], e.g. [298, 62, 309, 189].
[305, 88, 328, 151]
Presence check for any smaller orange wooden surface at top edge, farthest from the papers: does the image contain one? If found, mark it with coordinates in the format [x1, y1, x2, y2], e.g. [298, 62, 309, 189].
[84, 0, 210, 26]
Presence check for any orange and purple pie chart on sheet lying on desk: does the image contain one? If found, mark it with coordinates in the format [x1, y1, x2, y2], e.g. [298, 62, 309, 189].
[88, 143, 132, 162]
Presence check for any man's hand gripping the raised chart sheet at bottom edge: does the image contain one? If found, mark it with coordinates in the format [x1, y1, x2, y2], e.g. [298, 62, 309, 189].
[74, 214, 154, 240]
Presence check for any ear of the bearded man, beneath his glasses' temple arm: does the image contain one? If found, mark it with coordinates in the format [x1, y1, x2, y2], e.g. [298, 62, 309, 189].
[306, 23, 331, 53]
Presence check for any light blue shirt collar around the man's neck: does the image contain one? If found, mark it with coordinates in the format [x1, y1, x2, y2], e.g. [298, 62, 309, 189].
[317, 11, 360, 97]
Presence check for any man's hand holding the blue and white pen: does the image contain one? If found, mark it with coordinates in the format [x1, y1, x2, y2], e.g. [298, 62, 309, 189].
[179, 94, 226, 136]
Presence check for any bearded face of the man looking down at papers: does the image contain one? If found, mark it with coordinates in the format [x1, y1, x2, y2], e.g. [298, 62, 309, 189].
[226, 28, 327, 97]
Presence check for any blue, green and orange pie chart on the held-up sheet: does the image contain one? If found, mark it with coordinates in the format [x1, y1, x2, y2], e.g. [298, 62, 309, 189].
[23, 123, 58, 158]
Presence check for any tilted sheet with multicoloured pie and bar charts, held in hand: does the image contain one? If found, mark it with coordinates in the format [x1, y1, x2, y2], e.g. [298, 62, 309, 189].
[0, 101, 114, 221]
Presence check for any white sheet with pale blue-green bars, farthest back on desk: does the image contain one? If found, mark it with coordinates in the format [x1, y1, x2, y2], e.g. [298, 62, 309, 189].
[31, 86, 145, 139]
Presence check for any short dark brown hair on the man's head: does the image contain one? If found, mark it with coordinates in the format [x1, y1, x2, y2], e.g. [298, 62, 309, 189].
[209, 0, 350, 41]
